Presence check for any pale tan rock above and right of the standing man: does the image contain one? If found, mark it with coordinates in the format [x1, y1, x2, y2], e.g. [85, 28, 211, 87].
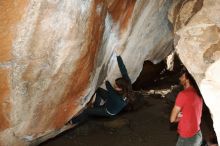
[169, 0, 220, 141]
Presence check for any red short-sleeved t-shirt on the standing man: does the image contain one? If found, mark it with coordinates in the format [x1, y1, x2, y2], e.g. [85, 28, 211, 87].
[175, 87, 203, 138]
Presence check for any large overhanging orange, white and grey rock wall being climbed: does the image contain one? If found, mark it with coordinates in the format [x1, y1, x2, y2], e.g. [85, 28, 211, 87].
[0, 0, 172, 146]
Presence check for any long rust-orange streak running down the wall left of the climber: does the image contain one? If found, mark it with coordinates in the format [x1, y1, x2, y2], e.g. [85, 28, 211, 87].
[51, 0, 106, 127]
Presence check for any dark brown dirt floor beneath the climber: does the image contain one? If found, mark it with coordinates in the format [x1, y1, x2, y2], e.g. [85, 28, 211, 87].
[40, 92, 177, 146]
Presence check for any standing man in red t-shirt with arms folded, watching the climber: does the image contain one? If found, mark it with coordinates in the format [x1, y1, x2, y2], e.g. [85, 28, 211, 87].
[170, 72, 203, 146]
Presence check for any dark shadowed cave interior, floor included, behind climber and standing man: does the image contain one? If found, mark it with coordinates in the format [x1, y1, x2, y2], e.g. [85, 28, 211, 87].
[40, 55, 215, 146]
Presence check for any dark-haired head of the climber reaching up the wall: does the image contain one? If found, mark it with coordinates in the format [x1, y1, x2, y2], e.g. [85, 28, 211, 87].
[115, 78, 131, 92]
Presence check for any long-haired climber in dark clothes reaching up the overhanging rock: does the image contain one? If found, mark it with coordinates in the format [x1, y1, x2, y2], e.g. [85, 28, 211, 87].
[69, 56, 136, 124]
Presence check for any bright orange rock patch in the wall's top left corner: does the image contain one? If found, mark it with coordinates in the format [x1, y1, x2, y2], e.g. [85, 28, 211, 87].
[0, 0, 27, 62]
